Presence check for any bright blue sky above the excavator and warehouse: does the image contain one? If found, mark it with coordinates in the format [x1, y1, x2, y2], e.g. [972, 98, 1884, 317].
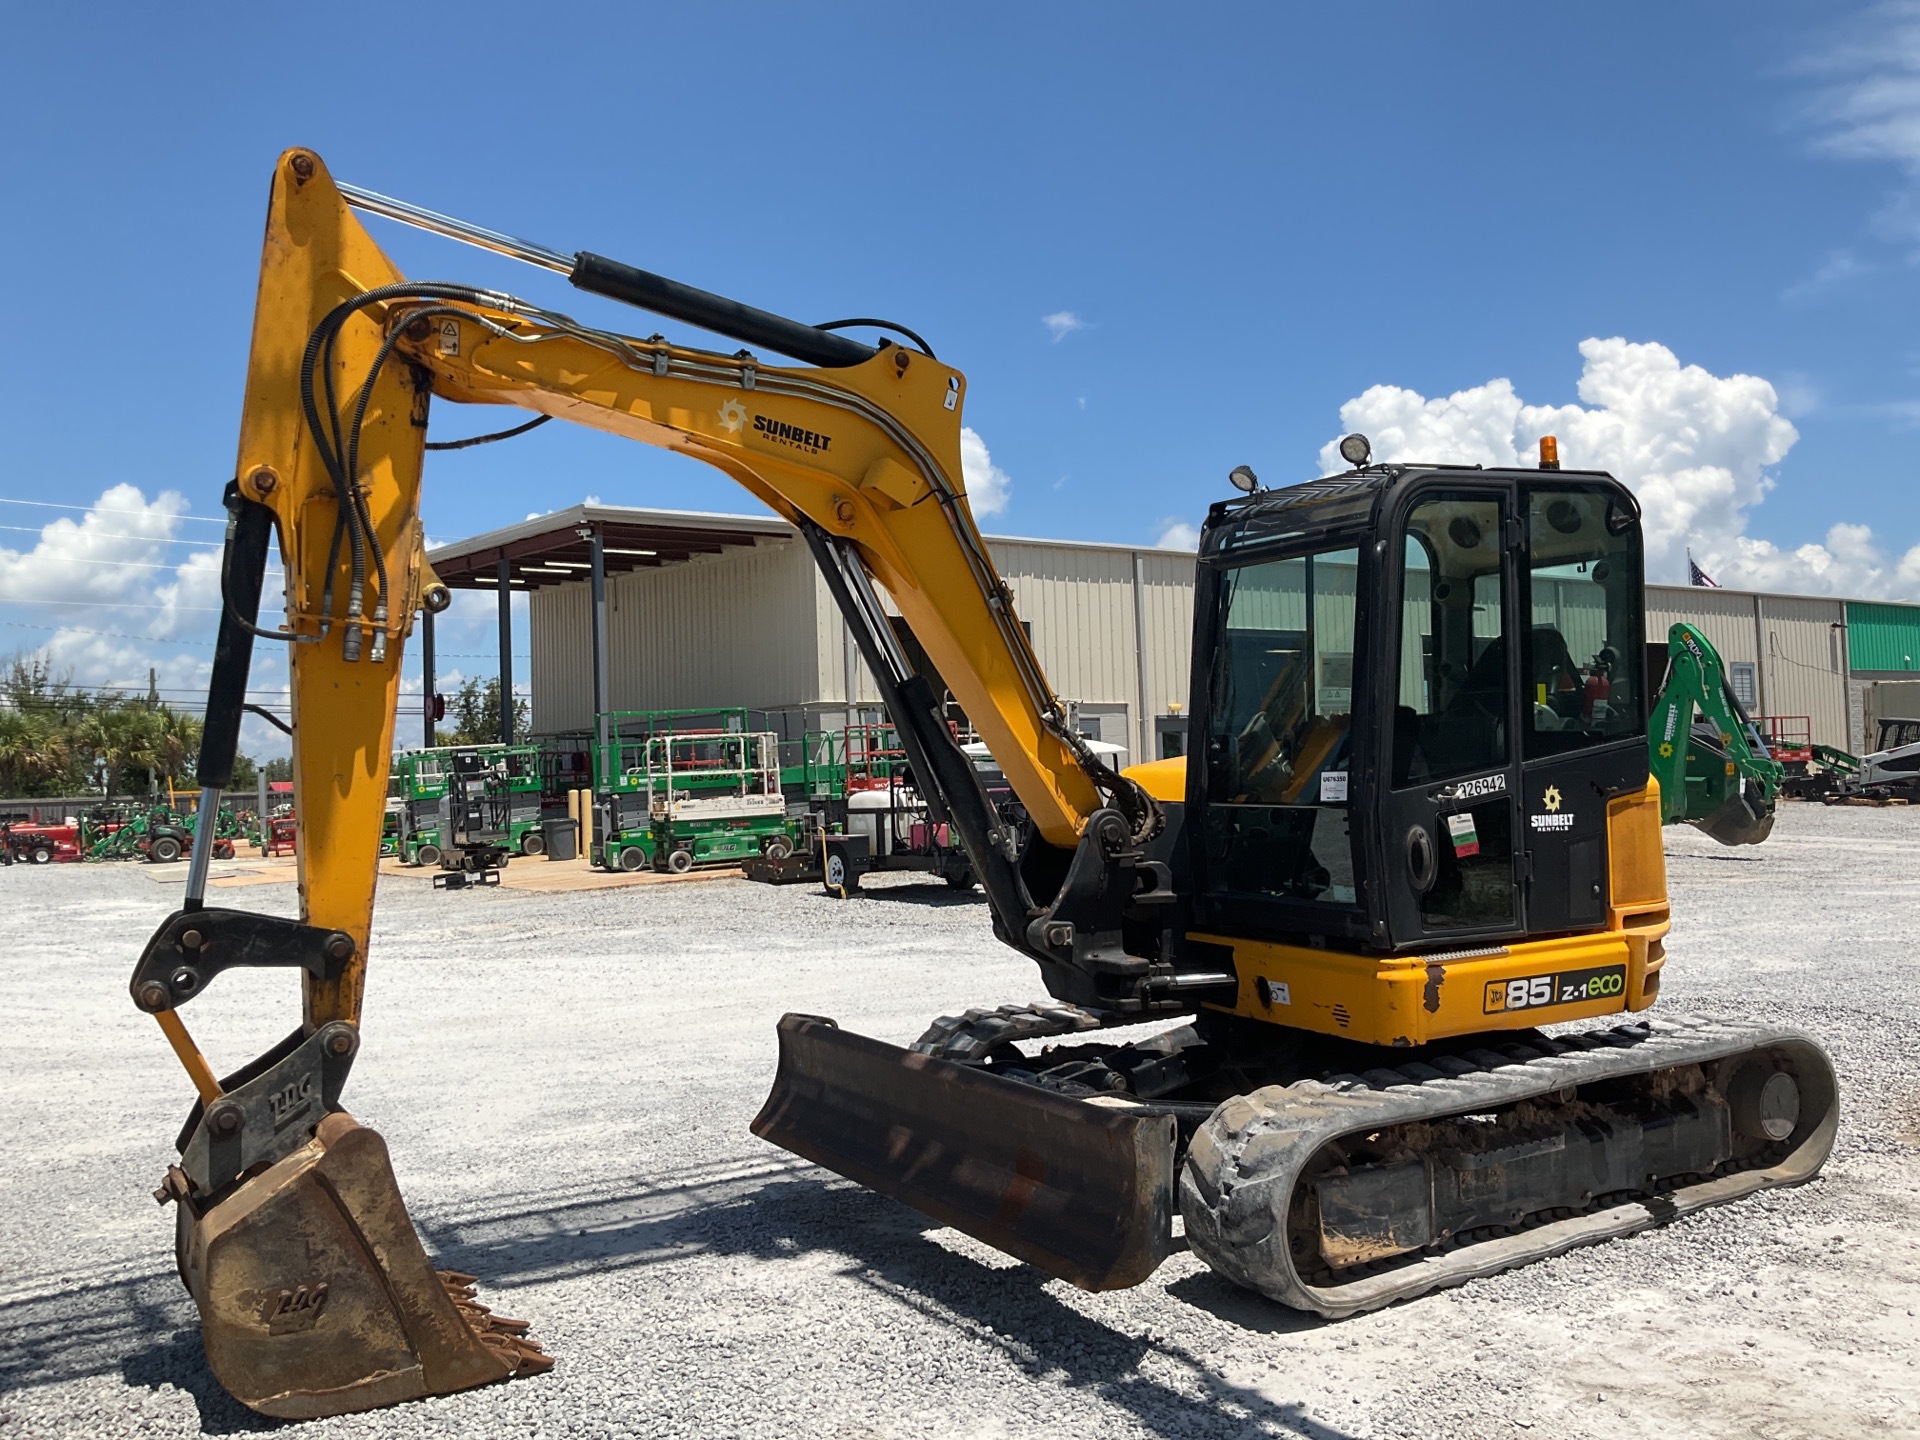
[0, 4, 1920, 737]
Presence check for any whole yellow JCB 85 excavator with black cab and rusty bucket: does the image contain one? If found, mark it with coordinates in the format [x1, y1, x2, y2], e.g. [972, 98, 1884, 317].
[131, 150, 1837, 1417]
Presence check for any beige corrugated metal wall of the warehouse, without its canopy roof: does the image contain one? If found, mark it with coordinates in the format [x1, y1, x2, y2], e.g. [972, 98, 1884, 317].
[532, 526, 1858, 755]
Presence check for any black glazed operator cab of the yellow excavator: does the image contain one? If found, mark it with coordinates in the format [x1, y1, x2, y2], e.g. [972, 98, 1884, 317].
[1187, 467, 1647, 950]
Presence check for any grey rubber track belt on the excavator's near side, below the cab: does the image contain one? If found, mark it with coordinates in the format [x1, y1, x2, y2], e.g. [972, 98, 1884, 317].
[1181, 1018, 1839, 1319]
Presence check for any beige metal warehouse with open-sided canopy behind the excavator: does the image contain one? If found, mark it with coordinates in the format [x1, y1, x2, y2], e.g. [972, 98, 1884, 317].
[424, 505, 1920, 762]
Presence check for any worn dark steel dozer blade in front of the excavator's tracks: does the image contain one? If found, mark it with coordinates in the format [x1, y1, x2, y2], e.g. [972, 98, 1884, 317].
[753, 1016, 1175, 1290]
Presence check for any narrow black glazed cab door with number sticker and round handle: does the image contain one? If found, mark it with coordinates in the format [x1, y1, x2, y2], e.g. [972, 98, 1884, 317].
[1380, 486, 1524, 945]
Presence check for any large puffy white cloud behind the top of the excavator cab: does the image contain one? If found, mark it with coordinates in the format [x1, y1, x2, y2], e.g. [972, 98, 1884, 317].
[1319, 338, 1920, 595]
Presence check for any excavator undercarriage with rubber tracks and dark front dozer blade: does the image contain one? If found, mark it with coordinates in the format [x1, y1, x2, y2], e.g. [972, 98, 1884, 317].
[755, 1002, 1837, 1317]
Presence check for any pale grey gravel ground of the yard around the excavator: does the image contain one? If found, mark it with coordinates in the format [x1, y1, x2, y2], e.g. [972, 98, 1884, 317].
[0, 804, 1920, 1440]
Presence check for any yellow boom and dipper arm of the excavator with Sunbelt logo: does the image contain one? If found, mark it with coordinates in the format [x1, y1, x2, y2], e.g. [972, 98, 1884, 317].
[236, 150, 1102, 1027]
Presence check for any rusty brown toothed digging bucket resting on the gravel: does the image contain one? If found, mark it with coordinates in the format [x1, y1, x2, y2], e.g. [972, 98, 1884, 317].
[180, 1114, 553, 1419]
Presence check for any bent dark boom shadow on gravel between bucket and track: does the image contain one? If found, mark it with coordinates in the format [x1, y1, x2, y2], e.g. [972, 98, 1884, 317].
[420, 1167, 1344, 1440]
